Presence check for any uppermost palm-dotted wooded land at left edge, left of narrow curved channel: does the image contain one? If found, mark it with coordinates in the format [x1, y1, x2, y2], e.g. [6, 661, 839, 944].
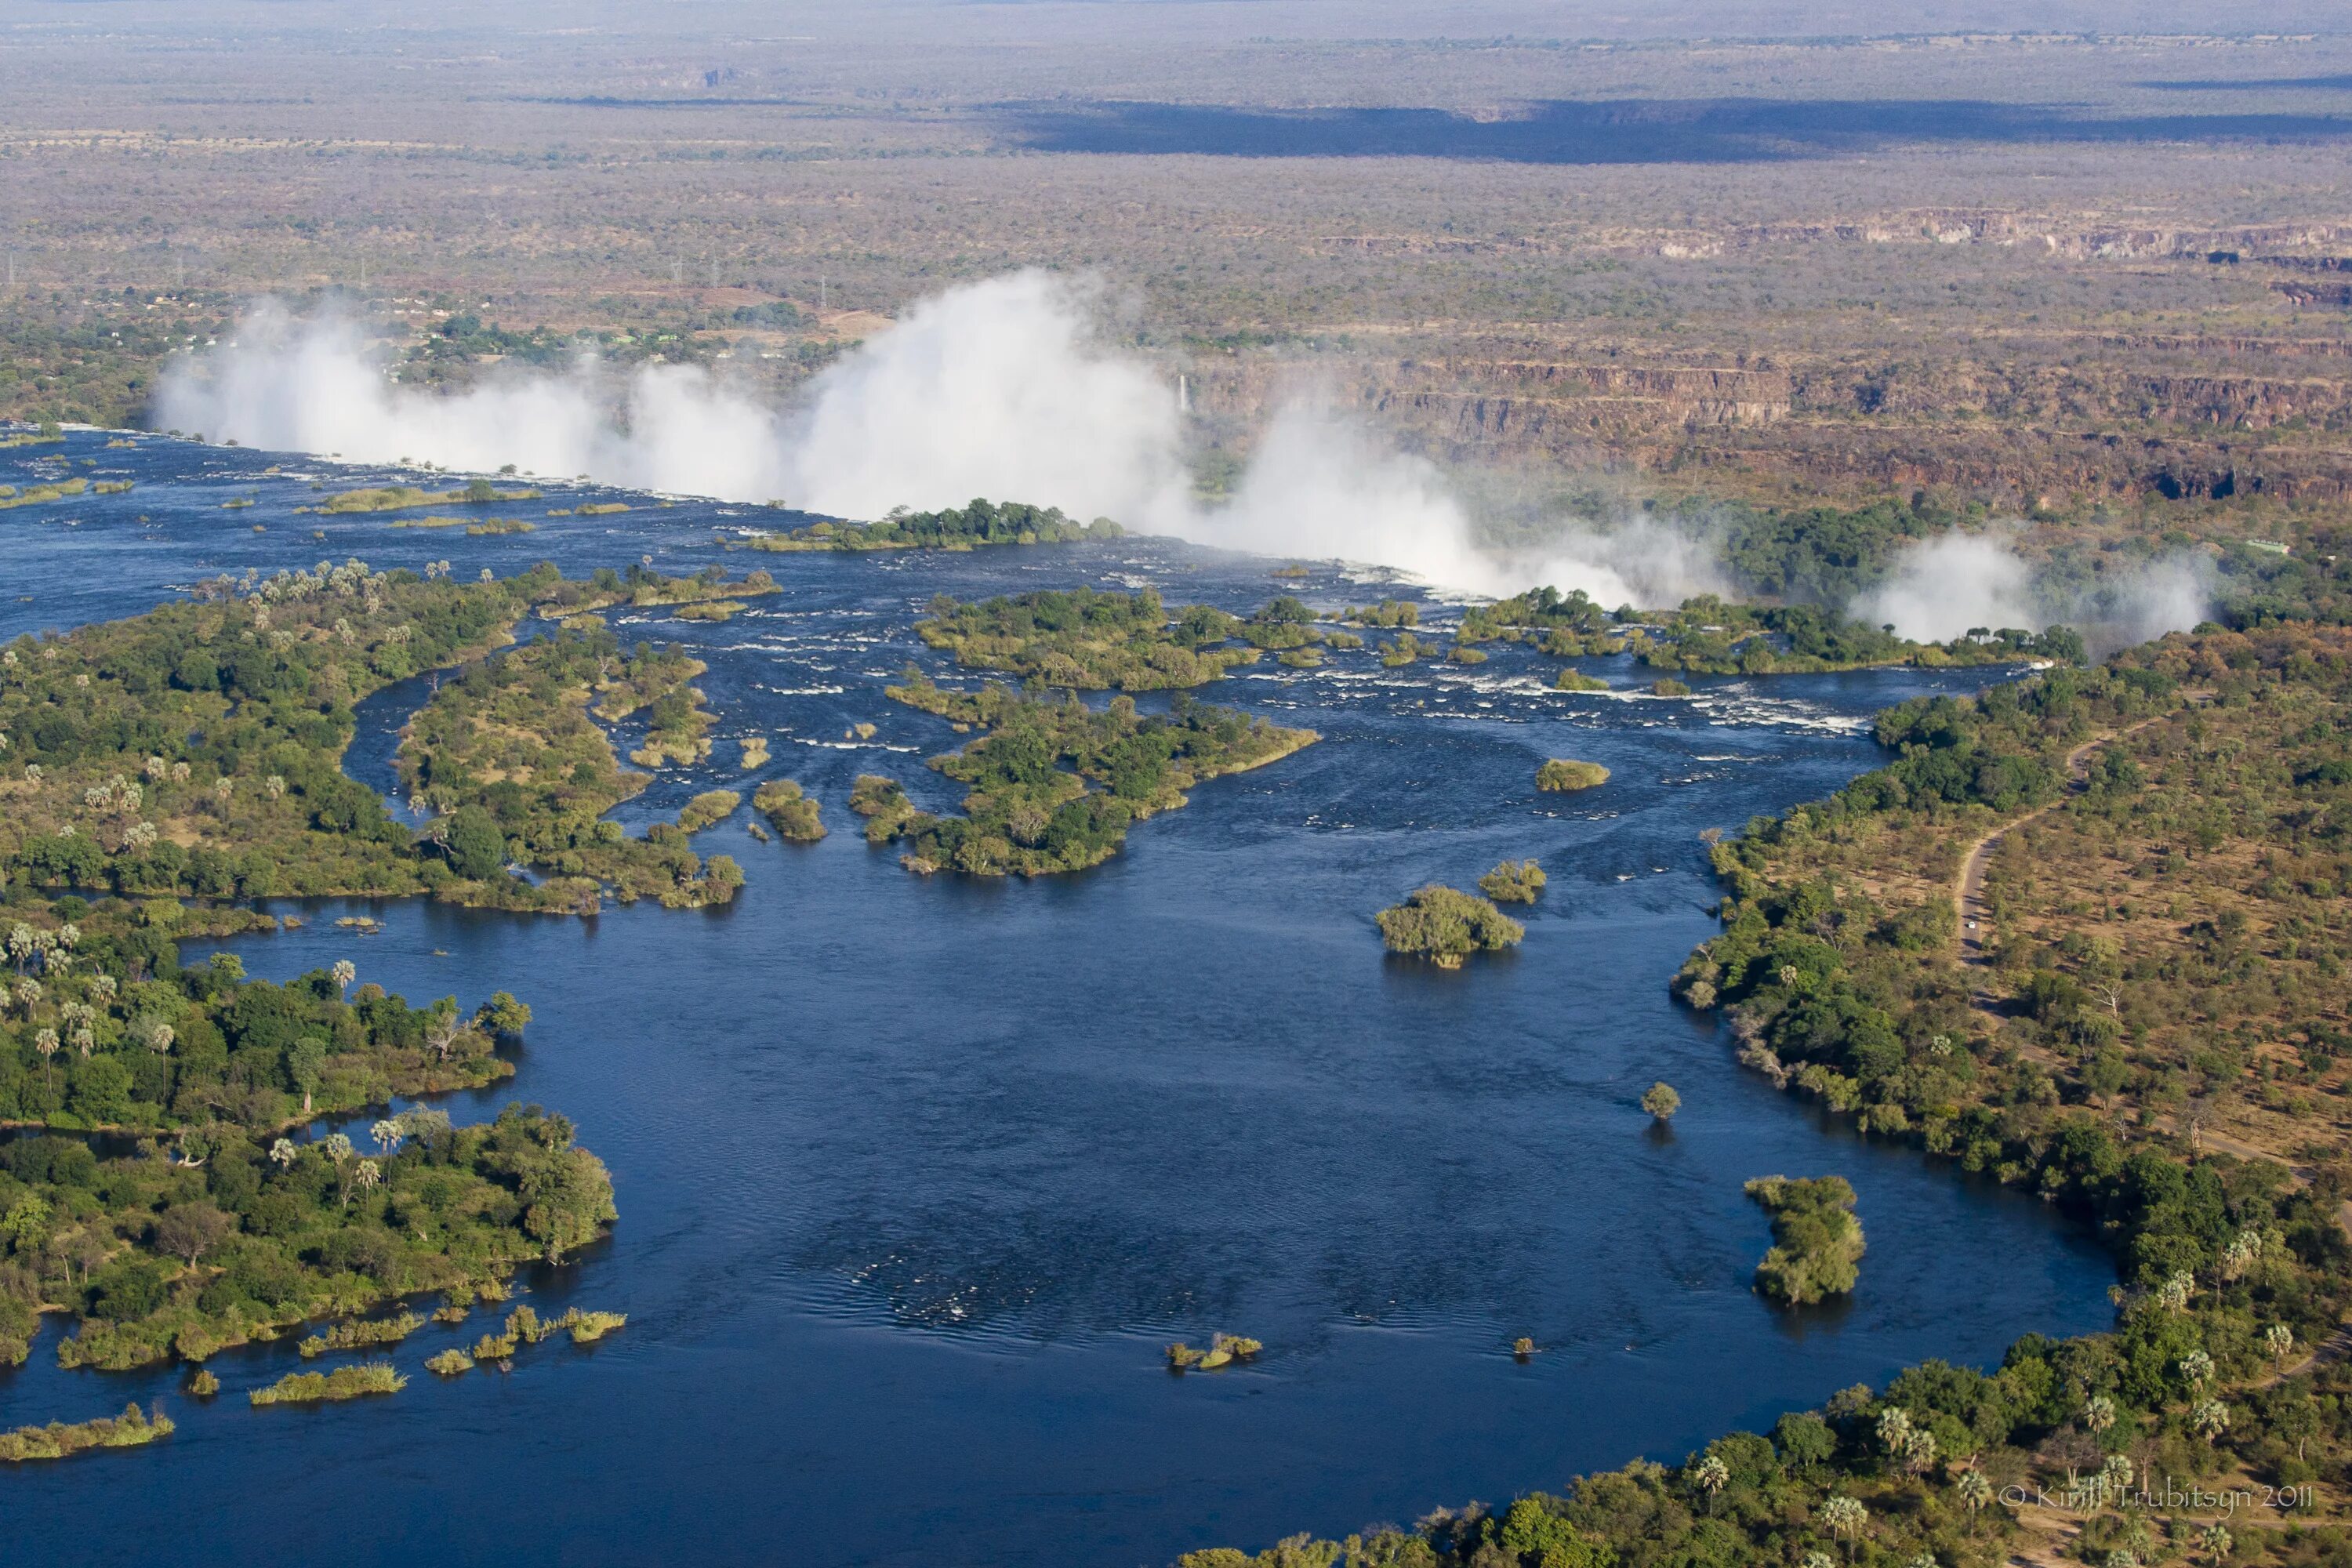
[0, 562, 539, 898]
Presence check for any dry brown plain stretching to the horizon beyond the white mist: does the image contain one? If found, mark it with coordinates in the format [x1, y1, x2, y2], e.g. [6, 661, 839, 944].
[0, 2, 2352, 532]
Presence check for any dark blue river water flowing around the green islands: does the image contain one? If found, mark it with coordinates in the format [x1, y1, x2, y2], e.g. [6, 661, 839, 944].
[0, 435, 2110, 1568]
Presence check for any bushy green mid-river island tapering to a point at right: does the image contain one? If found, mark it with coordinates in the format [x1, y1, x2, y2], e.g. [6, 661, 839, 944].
[870, 668, 1319, 877]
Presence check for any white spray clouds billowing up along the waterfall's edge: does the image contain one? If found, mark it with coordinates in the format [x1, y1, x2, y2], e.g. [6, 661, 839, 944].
[158, 270, 2211, 642]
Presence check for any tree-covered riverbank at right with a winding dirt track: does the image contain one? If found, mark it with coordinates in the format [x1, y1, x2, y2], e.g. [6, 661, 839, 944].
[1183, 628, 2352, 1568]
